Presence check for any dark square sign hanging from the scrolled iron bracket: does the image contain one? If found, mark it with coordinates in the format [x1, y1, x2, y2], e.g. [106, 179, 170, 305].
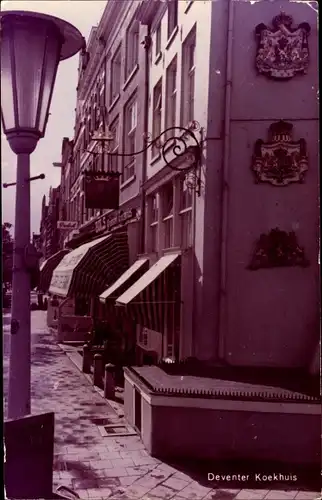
[84, 173, 119, 210]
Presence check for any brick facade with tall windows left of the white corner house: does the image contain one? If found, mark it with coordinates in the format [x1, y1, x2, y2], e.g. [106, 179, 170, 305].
[62, 2, 144, 260]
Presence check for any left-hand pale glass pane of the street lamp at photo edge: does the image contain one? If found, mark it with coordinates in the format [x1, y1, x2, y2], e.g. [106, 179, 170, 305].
[1, 33, 15, 131]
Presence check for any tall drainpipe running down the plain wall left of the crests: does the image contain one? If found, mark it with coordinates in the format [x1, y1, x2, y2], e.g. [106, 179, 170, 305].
[218, 0, 234, 359]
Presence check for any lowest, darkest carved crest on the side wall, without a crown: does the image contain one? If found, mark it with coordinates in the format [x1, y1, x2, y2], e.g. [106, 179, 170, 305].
[248, 228, 309, 271]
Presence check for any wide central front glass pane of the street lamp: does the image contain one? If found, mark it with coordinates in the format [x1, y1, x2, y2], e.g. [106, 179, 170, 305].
[13, 19, 46, 129]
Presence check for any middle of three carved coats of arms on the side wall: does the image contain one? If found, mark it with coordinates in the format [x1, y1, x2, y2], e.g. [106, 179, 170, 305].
[252, 120, 308, 186]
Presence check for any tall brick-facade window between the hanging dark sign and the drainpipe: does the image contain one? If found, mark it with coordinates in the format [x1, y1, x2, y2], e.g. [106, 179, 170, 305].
[122, 95, 137, 182]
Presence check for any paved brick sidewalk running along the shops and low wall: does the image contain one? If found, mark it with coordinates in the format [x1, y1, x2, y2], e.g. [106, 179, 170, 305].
[4, 311, 319, 500]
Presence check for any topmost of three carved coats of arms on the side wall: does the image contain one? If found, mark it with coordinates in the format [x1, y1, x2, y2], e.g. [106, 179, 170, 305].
[255, 12, 311, 80]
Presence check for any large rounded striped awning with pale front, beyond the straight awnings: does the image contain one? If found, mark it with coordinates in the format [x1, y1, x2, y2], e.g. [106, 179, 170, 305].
[49, 232, 129, 297]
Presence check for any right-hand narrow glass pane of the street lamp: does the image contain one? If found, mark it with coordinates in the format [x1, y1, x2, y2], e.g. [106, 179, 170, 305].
[38, 31, 61, 135]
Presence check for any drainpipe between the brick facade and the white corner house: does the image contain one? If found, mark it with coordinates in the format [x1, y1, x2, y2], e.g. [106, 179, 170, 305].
[139, 24, 151, 254]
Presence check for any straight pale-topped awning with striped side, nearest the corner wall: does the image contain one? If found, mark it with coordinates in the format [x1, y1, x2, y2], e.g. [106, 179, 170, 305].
[116, 252, 181, 332]
